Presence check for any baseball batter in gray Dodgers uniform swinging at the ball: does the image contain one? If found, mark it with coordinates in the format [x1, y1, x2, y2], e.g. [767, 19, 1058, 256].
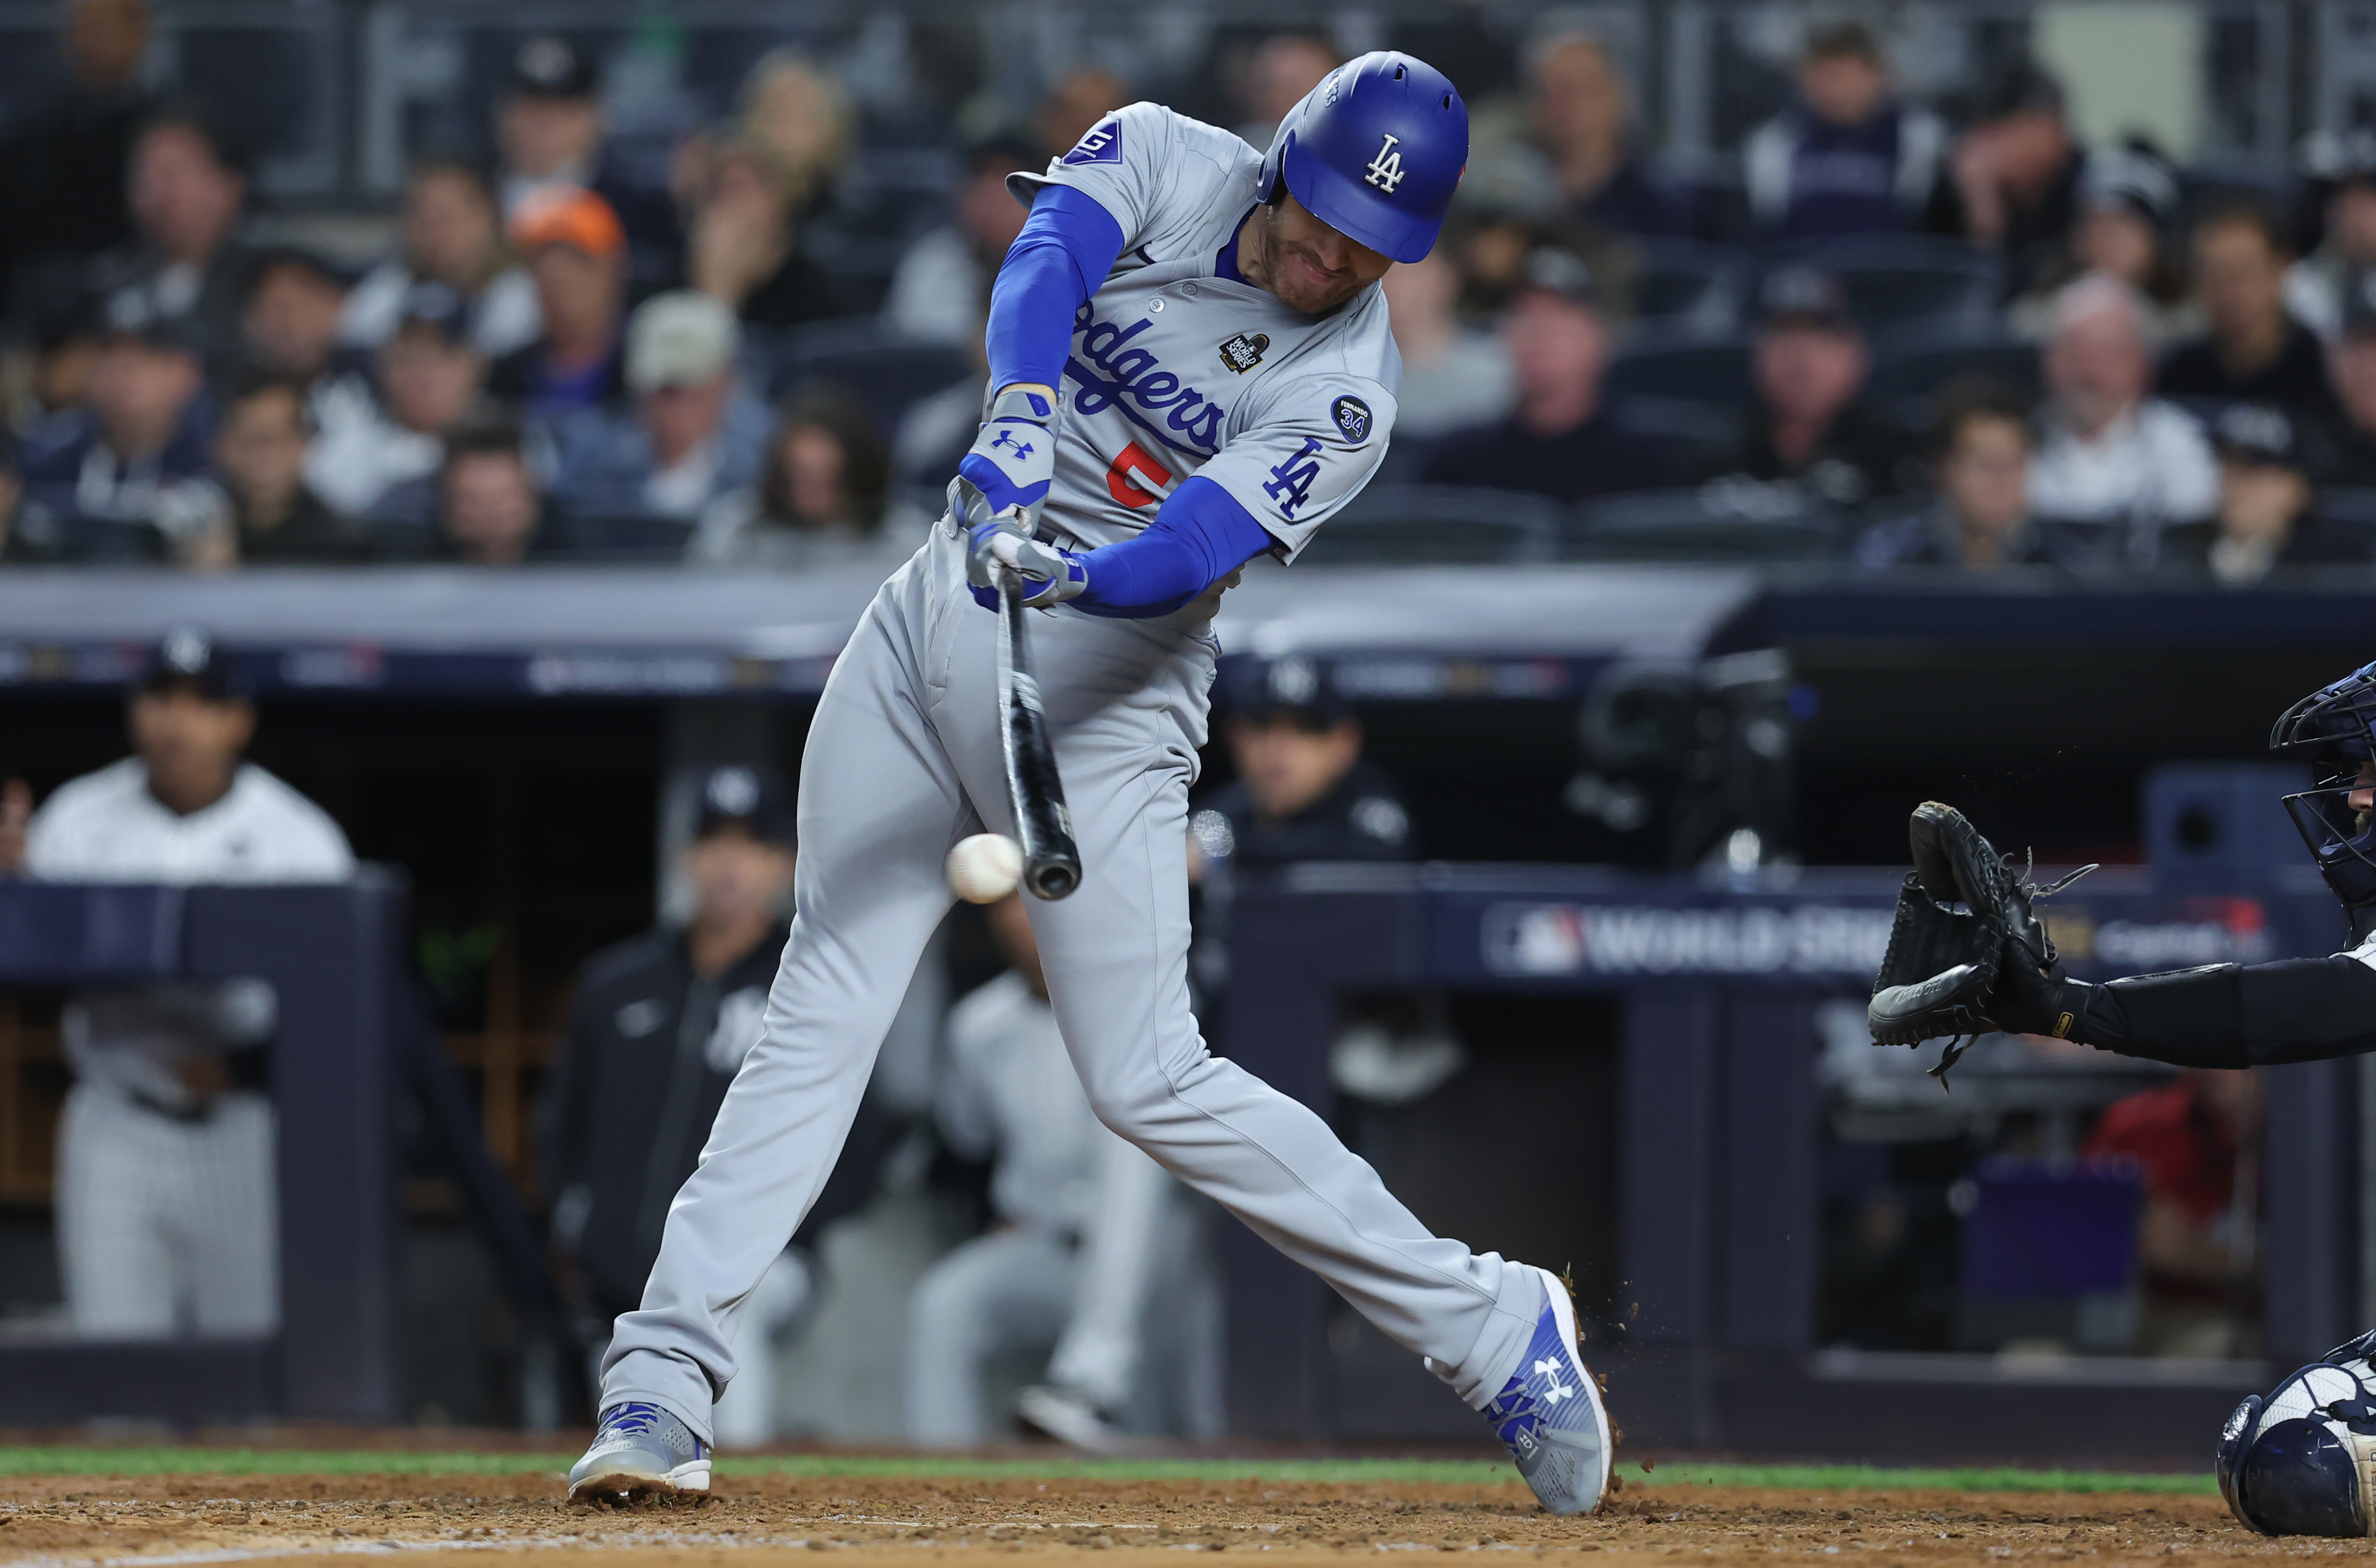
[570, 52, 1611, 1513]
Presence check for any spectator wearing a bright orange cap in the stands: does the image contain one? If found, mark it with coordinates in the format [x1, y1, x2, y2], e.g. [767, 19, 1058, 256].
[487, 185, 627, 418]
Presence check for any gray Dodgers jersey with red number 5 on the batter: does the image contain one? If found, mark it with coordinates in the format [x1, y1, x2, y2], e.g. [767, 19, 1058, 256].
[1008, 105, 1402, 561]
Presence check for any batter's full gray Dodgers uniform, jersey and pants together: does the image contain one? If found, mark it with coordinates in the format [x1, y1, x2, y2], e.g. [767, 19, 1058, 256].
[601, 105, 1545, 1433]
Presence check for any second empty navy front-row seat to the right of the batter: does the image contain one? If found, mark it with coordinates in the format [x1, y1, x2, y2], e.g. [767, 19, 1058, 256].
[1561, 480, 1844, 561]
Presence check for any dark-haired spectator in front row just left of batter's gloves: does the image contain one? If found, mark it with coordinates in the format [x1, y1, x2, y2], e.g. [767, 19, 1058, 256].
[687, 387, 931, 577]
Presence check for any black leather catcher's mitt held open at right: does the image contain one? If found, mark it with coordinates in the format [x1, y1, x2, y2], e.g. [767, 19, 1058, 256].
[1865, 801, 2096, 1083]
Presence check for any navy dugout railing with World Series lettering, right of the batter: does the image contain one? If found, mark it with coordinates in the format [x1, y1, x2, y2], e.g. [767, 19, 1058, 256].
[1221, 865, 2364, 1461]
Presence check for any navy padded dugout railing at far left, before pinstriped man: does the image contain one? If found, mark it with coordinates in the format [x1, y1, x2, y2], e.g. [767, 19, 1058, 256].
[0, 865, 559, 1425]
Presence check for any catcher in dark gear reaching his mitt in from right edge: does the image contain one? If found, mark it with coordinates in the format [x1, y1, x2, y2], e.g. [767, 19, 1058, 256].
[1867, 663, 2376, 1537]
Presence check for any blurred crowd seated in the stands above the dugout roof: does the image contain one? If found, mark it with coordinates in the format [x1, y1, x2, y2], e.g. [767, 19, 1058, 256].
[0, 0, 2376, 582]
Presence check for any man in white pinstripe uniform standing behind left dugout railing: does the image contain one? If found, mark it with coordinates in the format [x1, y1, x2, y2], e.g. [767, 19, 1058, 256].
[0, 632, 354, 1337]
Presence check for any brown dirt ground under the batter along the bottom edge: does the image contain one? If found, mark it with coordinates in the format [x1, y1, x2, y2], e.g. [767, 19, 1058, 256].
[0, 1473, 2300, 1568]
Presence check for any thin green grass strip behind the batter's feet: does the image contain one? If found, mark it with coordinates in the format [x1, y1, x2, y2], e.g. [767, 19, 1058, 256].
[0, 1445, 2217, 1497]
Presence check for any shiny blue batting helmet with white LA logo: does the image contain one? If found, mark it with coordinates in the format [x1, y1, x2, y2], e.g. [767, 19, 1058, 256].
[1262, 50, 1468, 261]
